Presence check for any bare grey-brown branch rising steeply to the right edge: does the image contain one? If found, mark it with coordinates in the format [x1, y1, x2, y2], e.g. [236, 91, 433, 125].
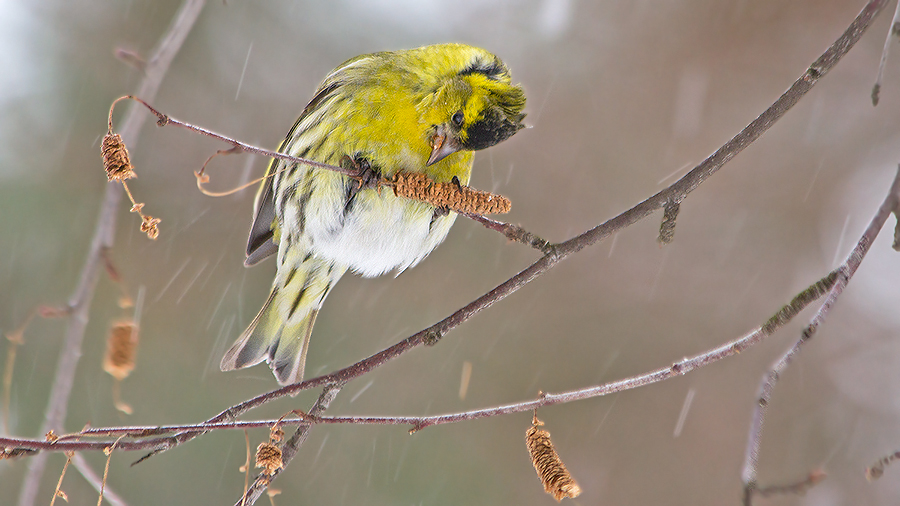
[741, 167, 900, 506]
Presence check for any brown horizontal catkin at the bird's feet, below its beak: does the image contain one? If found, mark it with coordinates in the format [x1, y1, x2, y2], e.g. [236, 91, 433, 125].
[392, 172, 512, 214]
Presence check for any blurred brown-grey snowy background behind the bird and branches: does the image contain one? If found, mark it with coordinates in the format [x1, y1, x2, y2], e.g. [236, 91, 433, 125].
[0, 0, 900, 505]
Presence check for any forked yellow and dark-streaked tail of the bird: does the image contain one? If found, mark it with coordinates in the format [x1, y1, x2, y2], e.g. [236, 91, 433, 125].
[220, 255, 347, 385]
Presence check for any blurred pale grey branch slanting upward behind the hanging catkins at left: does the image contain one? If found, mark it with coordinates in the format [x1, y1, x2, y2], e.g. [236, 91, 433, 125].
[18, 0, 205, 506]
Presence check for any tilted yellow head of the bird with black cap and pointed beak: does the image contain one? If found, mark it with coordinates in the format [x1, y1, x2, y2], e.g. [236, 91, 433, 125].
[420, 53, 525, 165]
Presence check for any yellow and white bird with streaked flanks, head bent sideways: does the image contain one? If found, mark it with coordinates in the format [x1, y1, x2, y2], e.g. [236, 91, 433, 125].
[221, 44, 525, 385]
